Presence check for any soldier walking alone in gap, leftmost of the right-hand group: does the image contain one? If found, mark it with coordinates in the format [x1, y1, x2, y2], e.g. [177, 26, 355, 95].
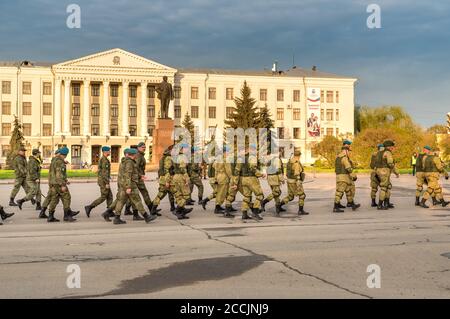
[333, 140, 361, 213]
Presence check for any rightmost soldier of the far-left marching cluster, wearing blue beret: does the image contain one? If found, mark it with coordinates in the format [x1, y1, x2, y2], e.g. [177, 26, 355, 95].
[47, 146, 79, 223]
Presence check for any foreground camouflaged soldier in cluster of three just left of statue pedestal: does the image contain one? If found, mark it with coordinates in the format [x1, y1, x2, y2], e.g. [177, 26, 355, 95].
[102, 148, 156, 225]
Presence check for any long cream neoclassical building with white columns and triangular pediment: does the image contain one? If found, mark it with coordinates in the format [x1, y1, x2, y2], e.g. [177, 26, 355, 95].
[0, 49, 356, 167]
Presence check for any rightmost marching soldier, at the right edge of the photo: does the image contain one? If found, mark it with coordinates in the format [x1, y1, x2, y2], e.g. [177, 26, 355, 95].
[420, 150, 450, 208]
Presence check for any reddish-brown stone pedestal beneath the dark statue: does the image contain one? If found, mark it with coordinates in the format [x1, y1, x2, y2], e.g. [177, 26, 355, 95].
[149, 119, 174, 170]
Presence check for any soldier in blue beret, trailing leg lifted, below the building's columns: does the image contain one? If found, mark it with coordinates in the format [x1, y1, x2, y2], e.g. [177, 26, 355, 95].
[84, 146, 113, 218]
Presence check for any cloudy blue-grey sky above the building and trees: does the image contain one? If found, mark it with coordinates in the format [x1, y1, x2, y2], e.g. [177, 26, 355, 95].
[0, 0, 450, 127]
